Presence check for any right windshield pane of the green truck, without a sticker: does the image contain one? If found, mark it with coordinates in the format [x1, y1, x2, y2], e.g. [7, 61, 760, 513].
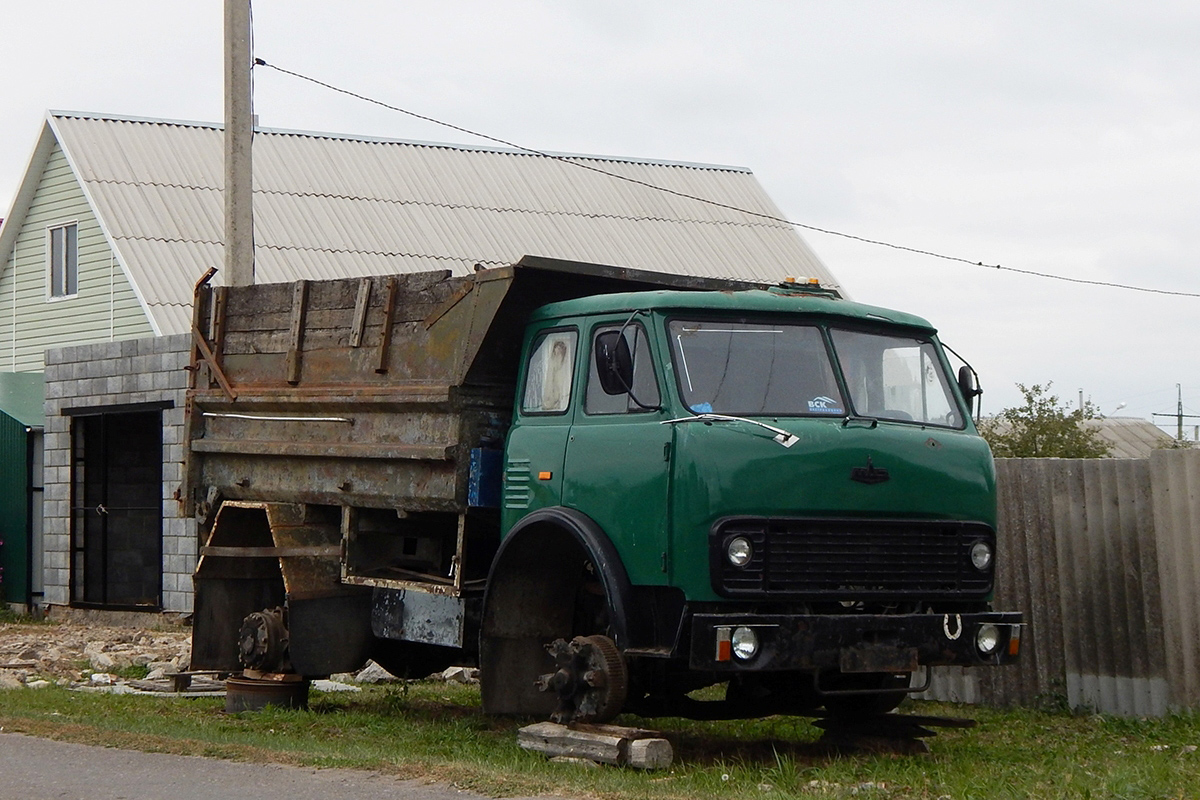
[830, 329, 964, 428]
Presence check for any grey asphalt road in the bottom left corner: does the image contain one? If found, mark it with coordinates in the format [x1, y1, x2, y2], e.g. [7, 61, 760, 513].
[0, 734, 566, 800]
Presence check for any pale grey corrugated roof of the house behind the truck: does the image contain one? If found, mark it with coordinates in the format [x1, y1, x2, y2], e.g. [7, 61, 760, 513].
[49, 113, 838, 333]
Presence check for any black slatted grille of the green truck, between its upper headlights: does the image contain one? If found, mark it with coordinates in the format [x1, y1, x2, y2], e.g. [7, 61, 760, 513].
[709, 518, 996, 601]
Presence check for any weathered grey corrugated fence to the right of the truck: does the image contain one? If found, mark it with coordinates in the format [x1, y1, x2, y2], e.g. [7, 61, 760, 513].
[923, 450, 1200, 715]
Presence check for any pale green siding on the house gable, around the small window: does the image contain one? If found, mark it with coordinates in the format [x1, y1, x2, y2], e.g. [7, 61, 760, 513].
[0, 145, 154, 372]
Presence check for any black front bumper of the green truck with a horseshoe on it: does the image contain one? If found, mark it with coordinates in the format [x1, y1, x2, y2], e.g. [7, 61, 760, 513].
[689, 612, 1024, 673]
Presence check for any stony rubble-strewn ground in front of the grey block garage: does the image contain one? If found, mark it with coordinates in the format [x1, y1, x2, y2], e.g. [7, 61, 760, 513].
[0, 621, 192, 687]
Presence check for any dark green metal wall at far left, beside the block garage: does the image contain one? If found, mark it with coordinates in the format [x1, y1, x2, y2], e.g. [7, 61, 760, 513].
[0, 411, 29, 603]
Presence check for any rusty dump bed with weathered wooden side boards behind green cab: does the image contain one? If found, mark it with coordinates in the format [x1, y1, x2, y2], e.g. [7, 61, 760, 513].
[184, 257, 744, 519]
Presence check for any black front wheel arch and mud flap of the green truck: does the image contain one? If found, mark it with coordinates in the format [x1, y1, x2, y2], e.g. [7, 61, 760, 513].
[479, 506, 634, 715]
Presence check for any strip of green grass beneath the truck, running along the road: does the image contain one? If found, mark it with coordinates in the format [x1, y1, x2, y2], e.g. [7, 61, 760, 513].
[0, 682, 1200, 800]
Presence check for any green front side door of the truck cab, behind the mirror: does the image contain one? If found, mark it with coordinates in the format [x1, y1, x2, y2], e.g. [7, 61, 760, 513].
[563, 319, 673, 585]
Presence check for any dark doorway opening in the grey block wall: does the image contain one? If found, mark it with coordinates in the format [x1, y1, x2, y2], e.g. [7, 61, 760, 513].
[71, 408, 163, 610]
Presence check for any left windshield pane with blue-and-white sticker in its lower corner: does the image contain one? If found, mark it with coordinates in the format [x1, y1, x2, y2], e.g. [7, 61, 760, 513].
[667, 319, 846, 416]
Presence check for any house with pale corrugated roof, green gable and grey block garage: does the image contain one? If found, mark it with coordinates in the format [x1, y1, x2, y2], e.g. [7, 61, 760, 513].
[0, 112, 836, 613]
